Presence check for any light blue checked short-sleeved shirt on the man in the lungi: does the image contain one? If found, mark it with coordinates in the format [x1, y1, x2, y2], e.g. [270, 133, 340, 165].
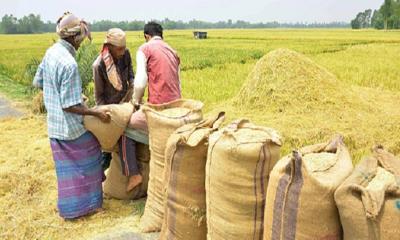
[33, 40, 86, 140]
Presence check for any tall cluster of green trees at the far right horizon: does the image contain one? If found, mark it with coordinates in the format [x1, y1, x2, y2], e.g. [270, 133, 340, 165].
[351, 0, 400, 29]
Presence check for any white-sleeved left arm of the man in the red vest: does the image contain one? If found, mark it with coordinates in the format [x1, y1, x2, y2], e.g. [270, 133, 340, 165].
[132, 50, 148, 104]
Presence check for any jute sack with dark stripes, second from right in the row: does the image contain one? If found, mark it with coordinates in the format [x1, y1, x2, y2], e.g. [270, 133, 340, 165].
[264, 136, 353, 240]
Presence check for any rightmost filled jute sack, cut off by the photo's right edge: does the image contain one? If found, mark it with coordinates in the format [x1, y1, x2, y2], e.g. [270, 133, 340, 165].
[335, 147, 400, 240]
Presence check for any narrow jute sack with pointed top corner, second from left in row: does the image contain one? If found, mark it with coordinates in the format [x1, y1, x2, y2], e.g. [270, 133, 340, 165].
[160, 113, 225, 240]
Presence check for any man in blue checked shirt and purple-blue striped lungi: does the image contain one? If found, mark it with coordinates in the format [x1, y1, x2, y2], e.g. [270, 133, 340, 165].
[33, 13, 110, 219]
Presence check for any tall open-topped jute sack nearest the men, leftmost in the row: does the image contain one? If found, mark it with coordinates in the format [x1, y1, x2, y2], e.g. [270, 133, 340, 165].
[140, 100, 203, 232]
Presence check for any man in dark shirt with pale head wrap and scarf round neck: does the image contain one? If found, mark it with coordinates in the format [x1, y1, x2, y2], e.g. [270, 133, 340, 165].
[93, 28, 142, 192]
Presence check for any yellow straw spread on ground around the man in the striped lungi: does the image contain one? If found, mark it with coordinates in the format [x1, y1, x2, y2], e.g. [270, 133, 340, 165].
[0, 116, 144, 240]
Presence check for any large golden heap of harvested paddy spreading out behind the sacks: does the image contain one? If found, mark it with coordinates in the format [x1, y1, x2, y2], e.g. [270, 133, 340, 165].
[212, 49, 400, 159]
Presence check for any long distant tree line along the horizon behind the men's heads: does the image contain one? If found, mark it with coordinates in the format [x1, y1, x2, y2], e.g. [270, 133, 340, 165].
[0, 14, 350, 34]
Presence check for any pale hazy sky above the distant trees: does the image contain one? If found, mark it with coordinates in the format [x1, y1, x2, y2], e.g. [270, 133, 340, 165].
[0, 0, 383, 22]
